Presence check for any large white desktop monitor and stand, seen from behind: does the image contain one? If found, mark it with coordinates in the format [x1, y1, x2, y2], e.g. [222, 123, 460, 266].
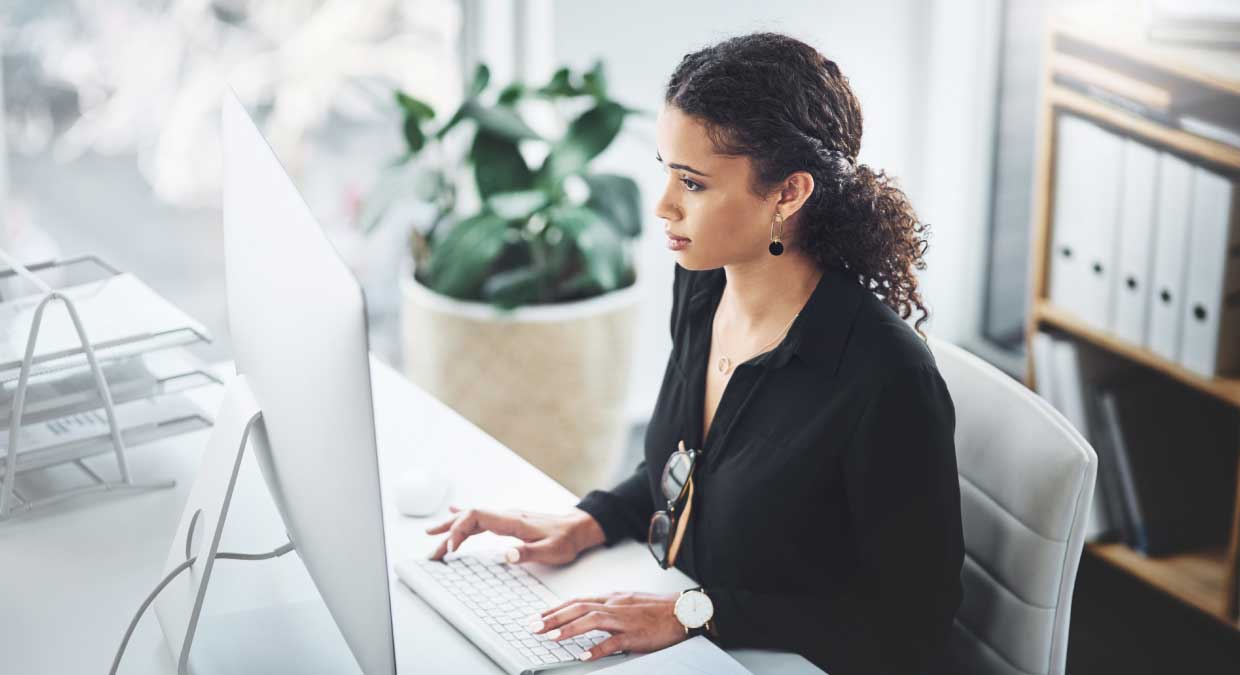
[156, 92, 396, 675]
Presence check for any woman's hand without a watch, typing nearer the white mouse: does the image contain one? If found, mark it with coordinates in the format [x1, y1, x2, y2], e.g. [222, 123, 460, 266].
[427, 506, 604, 565]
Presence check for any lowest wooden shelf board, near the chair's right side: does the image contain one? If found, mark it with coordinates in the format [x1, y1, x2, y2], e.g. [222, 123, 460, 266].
[1089, 543, 1240, 630]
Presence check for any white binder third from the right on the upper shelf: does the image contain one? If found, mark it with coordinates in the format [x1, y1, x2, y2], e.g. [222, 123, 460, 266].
[1111, 139, 1158, 345]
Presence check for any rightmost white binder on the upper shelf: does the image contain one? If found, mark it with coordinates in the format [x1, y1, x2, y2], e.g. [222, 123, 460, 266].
[1179, 166, 1240, 377]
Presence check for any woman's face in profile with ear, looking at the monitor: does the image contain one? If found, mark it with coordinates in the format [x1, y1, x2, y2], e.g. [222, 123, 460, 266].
[655, 105, 789, 269]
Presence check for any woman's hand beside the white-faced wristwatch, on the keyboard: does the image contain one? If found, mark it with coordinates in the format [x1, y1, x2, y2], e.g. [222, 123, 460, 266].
[531, 593, 684, 661]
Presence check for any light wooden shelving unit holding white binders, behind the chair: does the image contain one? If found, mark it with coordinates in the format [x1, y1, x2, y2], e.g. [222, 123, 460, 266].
[1025, 2, 1240, 634]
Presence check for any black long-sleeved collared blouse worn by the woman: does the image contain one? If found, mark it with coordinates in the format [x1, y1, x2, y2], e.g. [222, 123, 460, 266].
[578, 263, 963, 675]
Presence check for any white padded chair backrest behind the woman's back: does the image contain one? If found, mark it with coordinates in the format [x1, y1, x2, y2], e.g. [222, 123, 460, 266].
[929, 336, 1097, 675]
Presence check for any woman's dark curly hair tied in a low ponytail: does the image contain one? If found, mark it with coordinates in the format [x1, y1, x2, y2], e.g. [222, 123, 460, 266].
[665, 32, 930, 339]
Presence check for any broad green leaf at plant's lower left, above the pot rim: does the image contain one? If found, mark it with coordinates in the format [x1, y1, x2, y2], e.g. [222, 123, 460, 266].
[427, 212, 508, 299]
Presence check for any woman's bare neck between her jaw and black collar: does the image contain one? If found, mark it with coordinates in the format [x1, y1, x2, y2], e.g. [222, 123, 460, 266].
[715, 251, 822, 339]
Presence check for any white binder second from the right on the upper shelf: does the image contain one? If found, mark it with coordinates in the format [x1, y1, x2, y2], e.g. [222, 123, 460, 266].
[1147, 153, 1193, 361]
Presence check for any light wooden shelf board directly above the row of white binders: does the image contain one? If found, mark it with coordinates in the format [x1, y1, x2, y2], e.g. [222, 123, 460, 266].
[1048, 84, 1240, 170]
